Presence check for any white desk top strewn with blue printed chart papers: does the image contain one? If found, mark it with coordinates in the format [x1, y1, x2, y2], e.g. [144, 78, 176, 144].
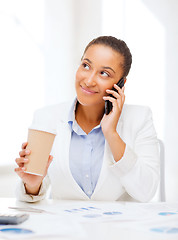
[0, 198, 178, 240]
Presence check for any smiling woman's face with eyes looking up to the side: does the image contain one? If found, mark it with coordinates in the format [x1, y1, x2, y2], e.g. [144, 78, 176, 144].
[75, 44, 124, 106]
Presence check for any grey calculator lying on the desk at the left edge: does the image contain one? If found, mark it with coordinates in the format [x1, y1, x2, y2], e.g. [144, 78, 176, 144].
[0, 213, 29, 225]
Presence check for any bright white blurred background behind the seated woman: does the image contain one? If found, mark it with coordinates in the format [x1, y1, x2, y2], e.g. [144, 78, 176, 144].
[0, 0, 178, 201]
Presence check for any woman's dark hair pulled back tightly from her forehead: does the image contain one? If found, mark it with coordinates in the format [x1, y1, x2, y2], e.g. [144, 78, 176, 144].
[83, 36, 132, 77]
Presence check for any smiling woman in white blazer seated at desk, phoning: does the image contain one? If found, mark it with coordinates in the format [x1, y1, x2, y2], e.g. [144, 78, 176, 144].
[15, 36, 159, 202]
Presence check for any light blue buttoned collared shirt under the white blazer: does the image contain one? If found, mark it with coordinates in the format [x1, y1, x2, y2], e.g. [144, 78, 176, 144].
[68, 102, 105, 198]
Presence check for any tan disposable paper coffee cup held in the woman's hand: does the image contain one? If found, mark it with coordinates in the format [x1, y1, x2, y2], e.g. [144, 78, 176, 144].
[24, 129, 56, 176]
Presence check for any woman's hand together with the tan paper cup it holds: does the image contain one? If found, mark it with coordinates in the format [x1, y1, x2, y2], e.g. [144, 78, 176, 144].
[15, 129, 55, 195]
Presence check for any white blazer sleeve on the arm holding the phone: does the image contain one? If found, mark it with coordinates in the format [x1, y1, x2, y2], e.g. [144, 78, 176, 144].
[111, 107, 160, 202]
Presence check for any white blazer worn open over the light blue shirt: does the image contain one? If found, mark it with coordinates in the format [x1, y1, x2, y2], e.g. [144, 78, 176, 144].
[16, 99, 160, 202]
